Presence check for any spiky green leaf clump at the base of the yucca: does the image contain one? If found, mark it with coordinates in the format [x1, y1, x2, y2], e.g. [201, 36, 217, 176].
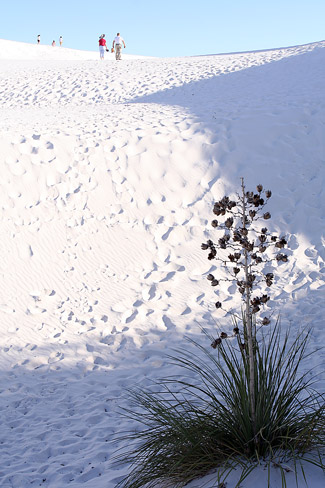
[115, 324, 325, 488]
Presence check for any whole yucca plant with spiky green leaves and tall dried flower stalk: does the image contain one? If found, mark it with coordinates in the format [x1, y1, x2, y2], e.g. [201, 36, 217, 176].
[115, 179, 325, 488]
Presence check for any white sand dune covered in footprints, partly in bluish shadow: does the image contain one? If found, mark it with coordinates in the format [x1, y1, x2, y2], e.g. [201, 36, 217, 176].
[0, 40, 325, 488]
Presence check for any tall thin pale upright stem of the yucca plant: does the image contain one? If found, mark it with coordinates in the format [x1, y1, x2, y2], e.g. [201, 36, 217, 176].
[241, 178, 256, 436]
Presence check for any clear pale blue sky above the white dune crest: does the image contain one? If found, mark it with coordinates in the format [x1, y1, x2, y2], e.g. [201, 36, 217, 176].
[0, 0, 325, 57]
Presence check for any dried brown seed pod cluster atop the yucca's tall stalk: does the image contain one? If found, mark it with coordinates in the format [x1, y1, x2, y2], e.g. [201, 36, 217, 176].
[201, 179, 288, 348]
